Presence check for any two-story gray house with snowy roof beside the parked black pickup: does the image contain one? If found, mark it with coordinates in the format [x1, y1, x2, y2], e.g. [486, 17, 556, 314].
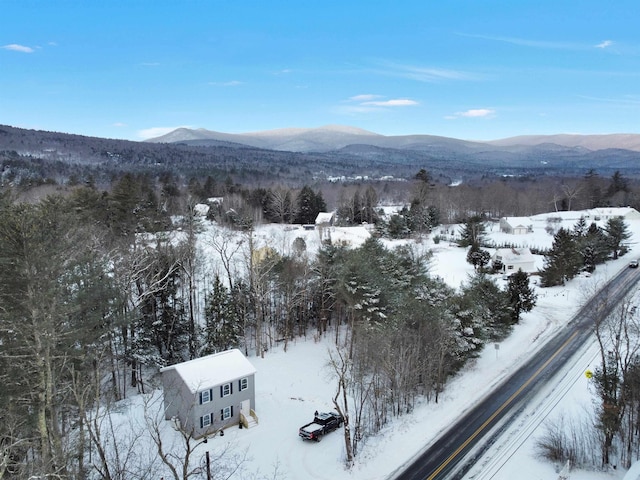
[160, 349, 257, 438]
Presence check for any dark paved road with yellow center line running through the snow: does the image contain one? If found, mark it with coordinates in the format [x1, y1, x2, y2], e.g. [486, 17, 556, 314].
[394, 268, 640, 480]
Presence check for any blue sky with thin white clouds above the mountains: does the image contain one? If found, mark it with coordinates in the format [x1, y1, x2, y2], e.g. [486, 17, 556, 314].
[0, 0, 640, 140]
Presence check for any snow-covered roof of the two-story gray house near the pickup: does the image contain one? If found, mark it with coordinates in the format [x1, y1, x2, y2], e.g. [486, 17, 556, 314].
[160, 348, 256, 393]
